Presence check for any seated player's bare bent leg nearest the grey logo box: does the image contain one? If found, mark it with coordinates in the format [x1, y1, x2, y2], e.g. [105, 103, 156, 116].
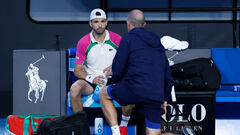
[70, 80, 94, 112]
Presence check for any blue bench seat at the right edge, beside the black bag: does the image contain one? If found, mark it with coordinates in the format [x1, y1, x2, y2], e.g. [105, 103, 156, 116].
[211, 48, 240, 119]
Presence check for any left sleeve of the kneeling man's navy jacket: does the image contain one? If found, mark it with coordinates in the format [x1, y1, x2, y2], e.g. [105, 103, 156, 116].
[112, 37, 129, 83]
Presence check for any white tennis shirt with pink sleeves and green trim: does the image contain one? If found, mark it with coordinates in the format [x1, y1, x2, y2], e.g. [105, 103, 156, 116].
[75, 30, 121, 75]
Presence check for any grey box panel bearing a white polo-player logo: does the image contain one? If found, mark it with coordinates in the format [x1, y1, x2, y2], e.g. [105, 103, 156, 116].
[13, 50, 66, 115]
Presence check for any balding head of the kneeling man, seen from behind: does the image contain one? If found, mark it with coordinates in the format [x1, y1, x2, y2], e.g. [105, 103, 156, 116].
[127, 9, 145, 27]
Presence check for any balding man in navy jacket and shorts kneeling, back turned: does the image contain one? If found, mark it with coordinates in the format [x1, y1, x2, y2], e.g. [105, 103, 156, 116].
[99, 10, 173, 135]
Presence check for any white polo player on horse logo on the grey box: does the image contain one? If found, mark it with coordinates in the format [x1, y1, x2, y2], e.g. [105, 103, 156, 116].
[25, 55, 48, 103]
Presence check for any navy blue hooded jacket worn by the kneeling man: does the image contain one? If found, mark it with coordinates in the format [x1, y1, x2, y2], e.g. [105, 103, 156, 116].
[112, 28, 173, 102]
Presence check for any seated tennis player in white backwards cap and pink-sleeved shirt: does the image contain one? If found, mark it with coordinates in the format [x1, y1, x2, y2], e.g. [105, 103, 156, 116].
[70, 9, 131, 134]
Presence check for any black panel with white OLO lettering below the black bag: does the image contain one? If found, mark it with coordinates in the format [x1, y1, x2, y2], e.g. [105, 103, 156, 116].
[162, 92, 215, 135]
